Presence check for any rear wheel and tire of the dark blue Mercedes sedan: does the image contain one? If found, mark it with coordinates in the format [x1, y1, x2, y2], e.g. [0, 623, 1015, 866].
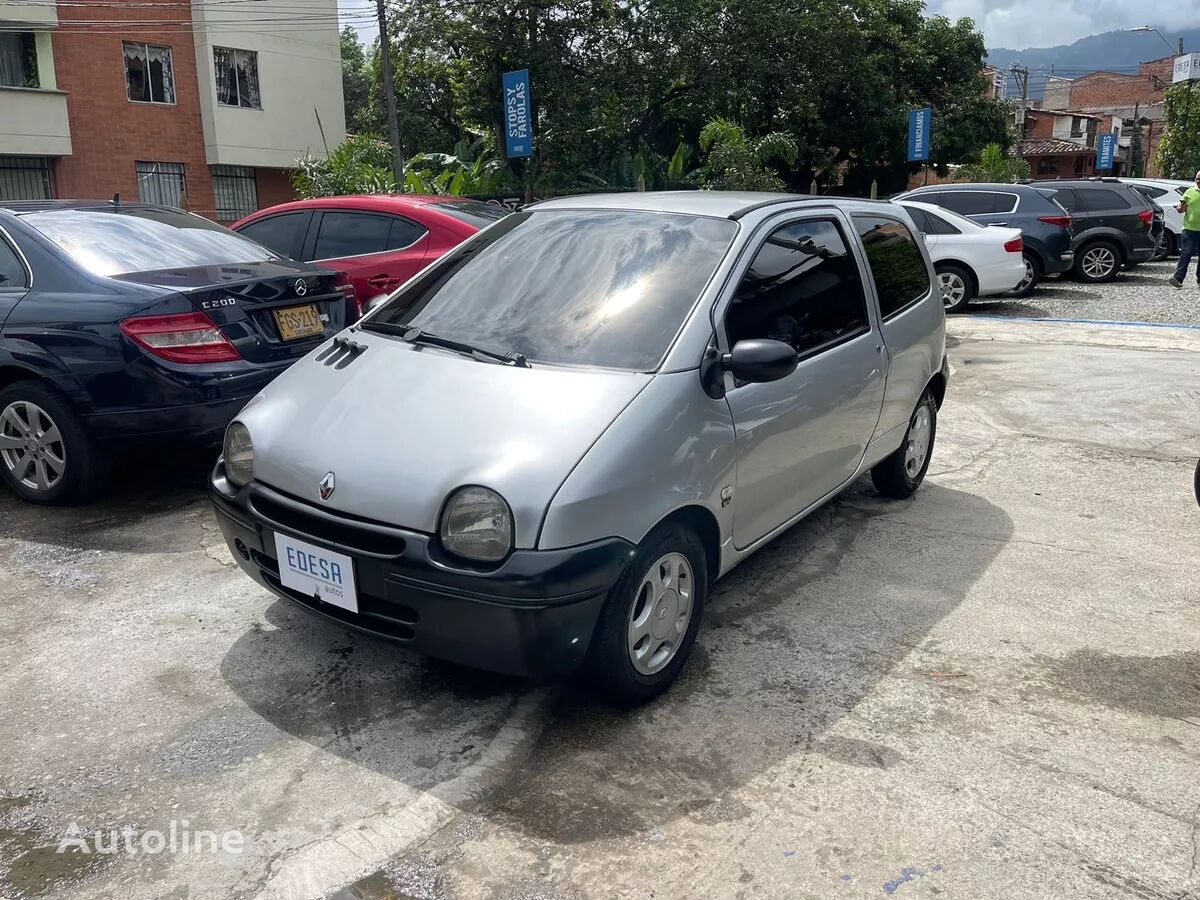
[0, 380, 103, 506]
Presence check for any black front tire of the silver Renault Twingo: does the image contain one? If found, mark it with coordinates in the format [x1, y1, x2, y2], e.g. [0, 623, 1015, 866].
[586, 524, 708, 707]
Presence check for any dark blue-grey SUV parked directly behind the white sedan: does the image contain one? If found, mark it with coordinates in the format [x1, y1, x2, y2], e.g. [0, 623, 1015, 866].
[895, 184, 1075, 296]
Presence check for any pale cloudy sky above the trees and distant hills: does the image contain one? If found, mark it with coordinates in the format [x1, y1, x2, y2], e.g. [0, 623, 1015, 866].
[337, 0, 1200, 50]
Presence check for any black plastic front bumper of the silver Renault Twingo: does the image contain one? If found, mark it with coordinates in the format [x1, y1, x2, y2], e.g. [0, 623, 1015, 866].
[209, 461, 634, 677]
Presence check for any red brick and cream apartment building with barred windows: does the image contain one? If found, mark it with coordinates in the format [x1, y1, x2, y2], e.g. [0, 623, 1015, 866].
[0, 0, 346, 221]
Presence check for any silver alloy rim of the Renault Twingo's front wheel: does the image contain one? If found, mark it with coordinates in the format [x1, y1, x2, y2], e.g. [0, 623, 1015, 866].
[628, 553, 696, 676]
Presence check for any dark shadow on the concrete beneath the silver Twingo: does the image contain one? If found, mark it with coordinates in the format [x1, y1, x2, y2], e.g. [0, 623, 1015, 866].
[221, 482, 1013, 844]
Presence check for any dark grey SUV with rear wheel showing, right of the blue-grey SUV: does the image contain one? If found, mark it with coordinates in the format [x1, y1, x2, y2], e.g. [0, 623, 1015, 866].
[1038, 178, 1163, 282]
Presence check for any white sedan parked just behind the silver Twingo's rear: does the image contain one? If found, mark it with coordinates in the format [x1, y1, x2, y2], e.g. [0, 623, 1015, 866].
[900, 200, 1025, 312]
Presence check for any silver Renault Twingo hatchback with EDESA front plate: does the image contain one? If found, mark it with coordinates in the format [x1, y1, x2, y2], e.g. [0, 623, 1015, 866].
[211, 192, 948, 703]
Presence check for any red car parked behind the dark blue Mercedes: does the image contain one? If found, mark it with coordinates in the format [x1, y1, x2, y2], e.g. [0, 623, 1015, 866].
[233, 193, 509, 310]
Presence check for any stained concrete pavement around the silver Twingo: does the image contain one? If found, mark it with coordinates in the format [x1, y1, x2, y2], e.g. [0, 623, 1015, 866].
[0, 317, 1200, 900]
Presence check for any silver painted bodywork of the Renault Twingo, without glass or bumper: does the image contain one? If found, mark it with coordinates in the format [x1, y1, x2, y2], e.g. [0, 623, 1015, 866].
[238, 191, 946, 574]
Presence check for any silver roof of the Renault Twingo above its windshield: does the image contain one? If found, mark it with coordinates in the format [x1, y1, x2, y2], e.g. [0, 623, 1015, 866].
[523, 191, 888, 218]
